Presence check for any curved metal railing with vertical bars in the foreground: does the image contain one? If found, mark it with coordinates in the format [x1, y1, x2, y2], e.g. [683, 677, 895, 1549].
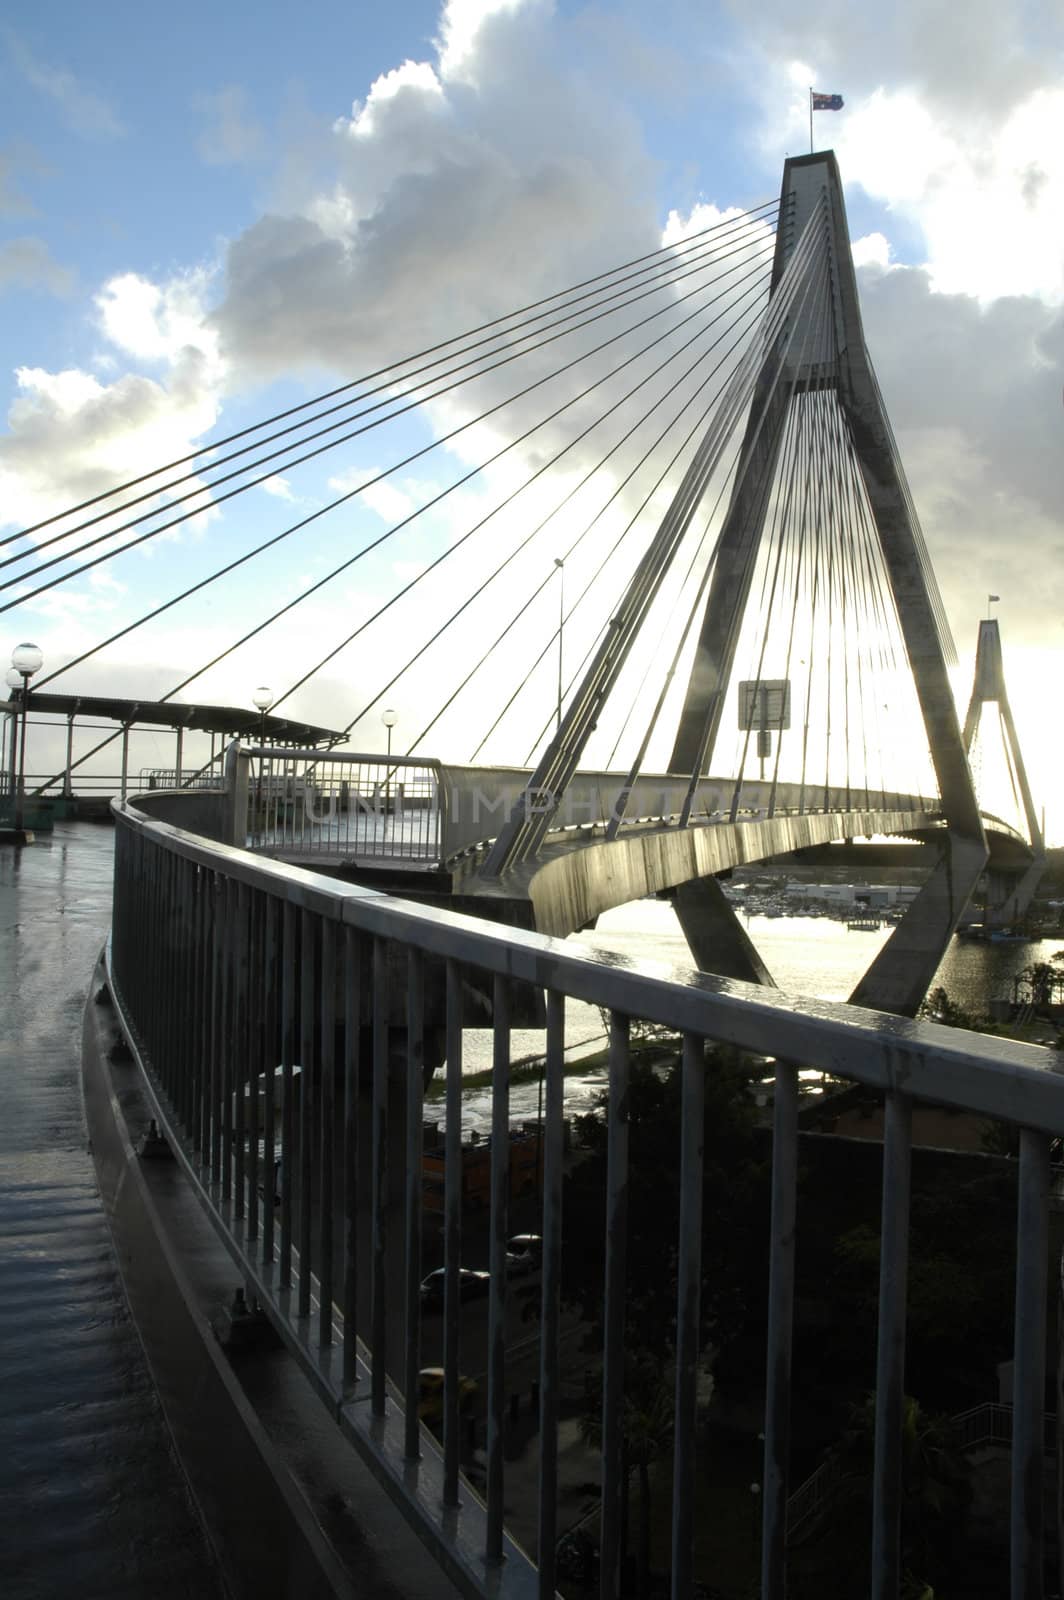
[109, 805, 1064, 1600]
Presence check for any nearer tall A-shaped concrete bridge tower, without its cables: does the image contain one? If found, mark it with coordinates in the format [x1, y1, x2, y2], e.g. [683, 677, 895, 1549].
[670, 150, 987, 1014]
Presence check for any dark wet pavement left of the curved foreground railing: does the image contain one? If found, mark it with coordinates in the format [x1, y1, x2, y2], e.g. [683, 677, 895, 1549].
[0, 822, 224, 1600]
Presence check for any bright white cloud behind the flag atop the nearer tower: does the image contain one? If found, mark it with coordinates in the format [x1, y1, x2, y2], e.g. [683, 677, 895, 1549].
[742, 0, 1064, 302]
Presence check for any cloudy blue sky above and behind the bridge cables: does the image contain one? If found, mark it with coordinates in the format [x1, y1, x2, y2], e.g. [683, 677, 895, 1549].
[0, 0, 1064, 842]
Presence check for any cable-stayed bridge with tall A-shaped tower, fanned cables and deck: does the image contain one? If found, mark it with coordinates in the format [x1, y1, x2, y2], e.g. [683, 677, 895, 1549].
[5, 155, 1042, 1013]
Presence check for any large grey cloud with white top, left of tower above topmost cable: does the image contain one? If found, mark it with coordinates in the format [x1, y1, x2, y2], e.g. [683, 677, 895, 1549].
[214, 0, 658, 385]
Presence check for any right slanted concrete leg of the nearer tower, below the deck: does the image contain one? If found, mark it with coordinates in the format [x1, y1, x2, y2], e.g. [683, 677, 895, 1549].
[850, 834, 986, 1016]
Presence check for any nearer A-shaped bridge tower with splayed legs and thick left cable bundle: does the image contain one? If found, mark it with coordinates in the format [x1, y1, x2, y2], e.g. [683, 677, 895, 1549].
[483, 152, 987, 1014]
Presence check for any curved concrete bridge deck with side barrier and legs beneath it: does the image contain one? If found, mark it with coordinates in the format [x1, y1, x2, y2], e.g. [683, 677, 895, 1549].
[201, 744, 1032, 1014]
